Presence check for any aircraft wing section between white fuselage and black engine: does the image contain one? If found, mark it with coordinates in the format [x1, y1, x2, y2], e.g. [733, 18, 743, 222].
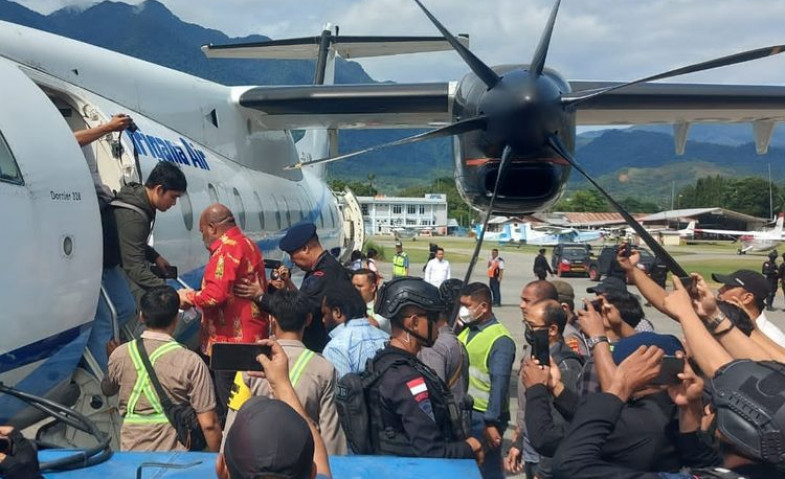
[236, 82, 456, 130]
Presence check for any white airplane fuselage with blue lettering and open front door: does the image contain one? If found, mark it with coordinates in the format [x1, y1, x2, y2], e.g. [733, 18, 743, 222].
[0, 22, 343, 423]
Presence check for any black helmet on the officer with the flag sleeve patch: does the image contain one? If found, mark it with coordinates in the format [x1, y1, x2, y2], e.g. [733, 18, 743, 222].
[374, 276, 444, 320]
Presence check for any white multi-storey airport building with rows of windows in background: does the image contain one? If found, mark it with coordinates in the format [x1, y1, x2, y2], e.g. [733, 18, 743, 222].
[357, 194, 447, 235]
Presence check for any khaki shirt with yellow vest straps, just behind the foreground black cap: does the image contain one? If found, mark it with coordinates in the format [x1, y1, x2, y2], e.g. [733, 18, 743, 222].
[222, 339, 346, 455]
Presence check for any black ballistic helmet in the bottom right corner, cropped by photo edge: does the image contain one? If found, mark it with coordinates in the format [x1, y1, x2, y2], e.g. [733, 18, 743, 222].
[711, 359, 785, 465]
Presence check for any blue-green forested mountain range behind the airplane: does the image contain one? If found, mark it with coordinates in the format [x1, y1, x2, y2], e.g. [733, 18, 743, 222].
[0, 0, 785, 201]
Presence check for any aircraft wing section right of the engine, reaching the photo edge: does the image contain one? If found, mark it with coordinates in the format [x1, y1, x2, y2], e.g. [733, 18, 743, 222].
[570, 81, 785, 125]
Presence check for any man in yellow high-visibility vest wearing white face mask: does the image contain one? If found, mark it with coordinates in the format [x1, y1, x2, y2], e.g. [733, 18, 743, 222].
[458, 283, 515, 479]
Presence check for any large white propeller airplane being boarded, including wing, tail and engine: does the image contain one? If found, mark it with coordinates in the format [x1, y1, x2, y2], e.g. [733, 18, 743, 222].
[0, 0, 785, 474]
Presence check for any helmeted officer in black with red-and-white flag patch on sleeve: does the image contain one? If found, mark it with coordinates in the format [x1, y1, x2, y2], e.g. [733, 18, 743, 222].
[367, 277, 484, 462]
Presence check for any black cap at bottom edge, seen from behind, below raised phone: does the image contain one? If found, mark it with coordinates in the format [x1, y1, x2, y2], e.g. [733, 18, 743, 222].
[224, 396, 314, 479]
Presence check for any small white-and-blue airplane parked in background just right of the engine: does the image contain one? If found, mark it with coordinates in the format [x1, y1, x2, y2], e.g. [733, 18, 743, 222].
[474, 222, 603, 246]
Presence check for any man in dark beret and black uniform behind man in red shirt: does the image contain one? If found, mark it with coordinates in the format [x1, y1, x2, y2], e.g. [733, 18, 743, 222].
[240, 223, 352, 353]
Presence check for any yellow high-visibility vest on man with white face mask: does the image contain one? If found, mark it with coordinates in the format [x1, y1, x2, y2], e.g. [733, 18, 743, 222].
[458, 323, 512, 412]
